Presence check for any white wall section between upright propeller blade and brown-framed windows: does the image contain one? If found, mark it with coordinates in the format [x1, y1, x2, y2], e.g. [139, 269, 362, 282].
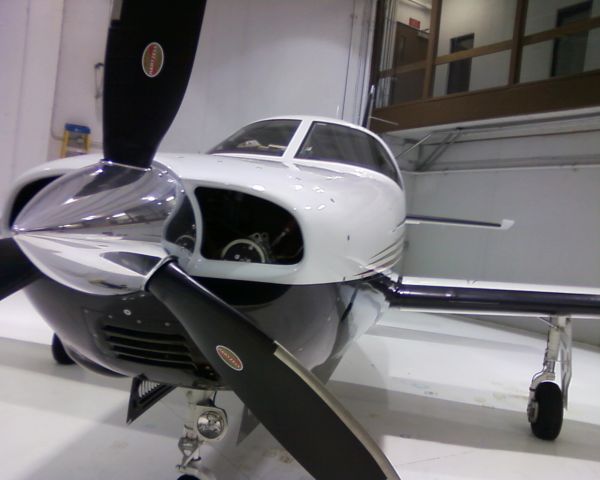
[163, 0, 371, 151]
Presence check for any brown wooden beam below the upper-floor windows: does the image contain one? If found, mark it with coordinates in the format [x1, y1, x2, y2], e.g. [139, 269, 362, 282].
[371, 70, 600, 133]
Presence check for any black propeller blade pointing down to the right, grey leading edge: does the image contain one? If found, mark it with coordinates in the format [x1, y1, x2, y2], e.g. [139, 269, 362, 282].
[147, 262, 398, 480]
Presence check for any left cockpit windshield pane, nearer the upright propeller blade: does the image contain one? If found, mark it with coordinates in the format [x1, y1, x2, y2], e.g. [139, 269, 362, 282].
[208, 120, 300, 157]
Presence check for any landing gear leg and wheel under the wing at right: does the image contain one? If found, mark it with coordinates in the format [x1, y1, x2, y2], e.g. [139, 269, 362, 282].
[527, 316, 573, 440]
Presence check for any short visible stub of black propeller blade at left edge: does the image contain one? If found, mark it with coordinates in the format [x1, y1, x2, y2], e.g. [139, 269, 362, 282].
[0, 238, 39, 300]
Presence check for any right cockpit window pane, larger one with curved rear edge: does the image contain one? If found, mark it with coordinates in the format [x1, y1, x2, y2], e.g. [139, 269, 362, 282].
[296, 122, 402, 187]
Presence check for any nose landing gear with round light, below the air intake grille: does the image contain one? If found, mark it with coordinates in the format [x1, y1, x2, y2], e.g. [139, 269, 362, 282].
[177, 390, 227, 480]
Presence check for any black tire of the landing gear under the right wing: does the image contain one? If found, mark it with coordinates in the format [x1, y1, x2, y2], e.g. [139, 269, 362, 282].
[530, 382, 563, 440]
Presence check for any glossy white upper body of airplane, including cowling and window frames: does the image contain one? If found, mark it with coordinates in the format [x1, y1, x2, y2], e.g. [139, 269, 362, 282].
[1, 117, 406, 285]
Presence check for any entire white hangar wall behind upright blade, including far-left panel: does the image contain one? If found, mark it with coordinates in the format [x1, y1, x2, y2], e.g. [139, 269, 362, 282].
[0, 0, 374, 192]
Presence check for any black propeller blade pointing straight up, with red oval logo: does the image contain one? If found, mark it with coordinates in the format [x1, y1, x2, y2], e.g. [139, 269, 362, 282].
[104, 0, 206, 168]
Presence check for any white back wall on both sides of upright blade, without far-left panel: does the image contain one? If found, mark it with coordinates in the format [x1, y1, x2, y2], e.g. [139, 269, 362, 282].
[53, 0, 373, 154]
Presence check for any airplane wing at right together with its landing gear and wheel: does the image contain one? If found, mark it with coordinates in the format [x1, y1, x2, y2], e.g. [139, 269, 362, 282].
[370, 274, 600, 440]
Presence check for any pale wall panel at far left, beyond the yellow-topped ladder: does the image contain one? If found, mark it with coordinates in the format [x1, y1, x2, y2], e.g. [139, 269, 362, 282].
[0, 0, 63, 202]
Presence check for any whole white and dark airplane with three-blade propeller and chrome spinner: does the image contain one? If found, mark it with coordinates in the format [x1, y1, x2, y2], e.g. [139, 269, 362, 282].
[0, 0, 600, 480]
